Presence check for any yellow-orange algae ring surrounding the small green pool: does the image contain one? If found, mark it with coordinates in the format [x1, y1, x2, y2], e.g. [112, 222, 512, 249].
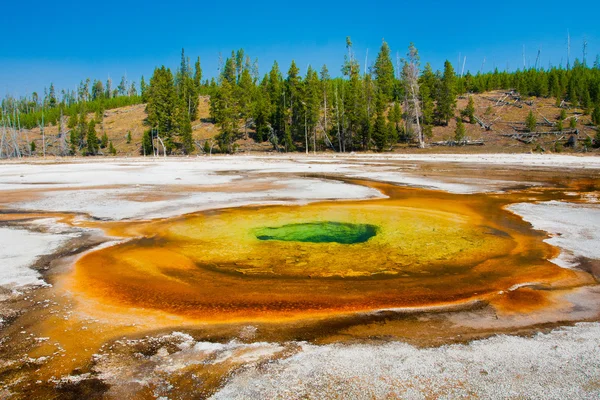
[64, 184, 580, 322]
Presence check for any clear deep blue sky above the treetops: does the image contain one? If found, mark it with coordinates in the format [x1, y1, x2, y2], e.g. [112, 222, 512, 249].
[0, 0, 600, 97]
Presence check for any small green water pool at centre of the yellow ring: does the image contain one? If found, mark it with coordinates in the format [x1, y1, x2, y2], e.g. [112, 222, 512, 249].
[254, 221, 377, 244]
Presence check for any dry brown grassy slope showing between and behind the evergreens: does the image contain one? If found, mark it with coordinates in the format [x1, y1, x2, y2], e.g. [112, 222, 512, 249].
[24, 91, 596, 156]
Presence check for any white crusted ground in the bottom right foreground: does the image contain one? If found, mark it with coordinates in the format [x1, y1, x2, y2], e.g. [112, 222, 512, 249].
[205, 323, 600, 399]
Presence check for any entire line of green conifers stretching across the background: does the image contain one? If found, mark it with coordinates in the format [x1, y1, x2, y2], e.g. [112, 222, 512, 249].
[1, 37, 600, 154]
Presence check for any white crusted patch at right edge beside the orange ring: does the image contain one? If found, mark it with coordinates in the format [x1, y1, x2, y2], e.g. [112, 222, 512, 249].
[506, 200, 600, 268]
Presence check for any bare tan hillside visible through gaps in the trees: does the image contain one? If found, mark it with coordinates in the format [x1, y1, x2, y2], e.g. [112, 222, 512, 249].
[23, 90, 598, 156]
